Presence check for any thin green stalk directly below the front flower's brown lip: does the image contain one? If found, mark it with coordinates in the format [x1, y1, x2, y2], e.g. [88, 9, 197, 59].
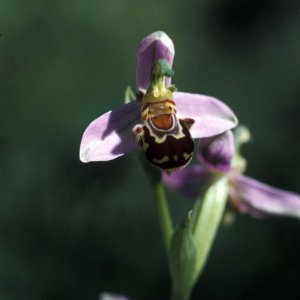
[154, 182, 173, 252]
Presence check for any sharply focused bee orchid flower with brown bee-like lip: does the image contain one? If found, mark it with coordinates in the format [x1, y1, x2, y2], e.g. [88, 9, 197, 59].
[80, 31, 237, 173]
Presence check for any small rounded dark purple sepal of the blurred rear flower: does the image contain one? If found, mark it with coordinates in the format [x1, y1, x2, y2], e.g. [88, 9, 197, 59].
[198, 130, 235, 172]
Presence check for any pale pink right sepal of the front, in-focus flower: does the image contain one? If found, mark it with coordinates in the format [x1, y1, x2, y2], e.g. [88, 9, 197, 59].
[174, 92, 238, 138]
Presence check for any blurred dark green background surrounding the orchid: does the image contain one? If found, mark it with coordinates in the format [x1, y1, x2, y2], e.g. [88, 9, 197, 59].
[0, 0, 300, 300]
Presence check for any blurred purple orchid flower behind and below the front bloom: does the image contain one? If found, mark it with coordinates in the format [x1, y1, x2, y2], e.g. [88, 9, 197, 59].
[163, 129, 300, 217]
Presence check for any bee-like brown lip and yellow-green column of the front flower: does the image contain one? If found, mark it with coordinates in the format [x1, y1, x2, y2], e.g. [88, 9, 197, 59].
[133, 60, 194, 174]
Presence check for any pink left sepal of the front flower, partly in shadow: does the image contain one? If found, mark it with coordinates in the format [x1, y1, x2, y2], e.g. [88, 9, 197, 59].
[80, 101, 140, 162]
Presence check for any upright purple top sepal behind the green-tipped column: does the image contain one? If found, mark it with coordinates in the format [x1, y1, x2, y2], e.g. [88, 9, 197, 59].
[136, 31, 175, 91]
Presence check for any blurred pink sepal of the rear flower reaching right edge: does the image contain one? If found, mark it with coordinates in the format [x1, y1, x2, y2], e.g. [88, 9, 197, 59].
[233, 175, 300, 218]
